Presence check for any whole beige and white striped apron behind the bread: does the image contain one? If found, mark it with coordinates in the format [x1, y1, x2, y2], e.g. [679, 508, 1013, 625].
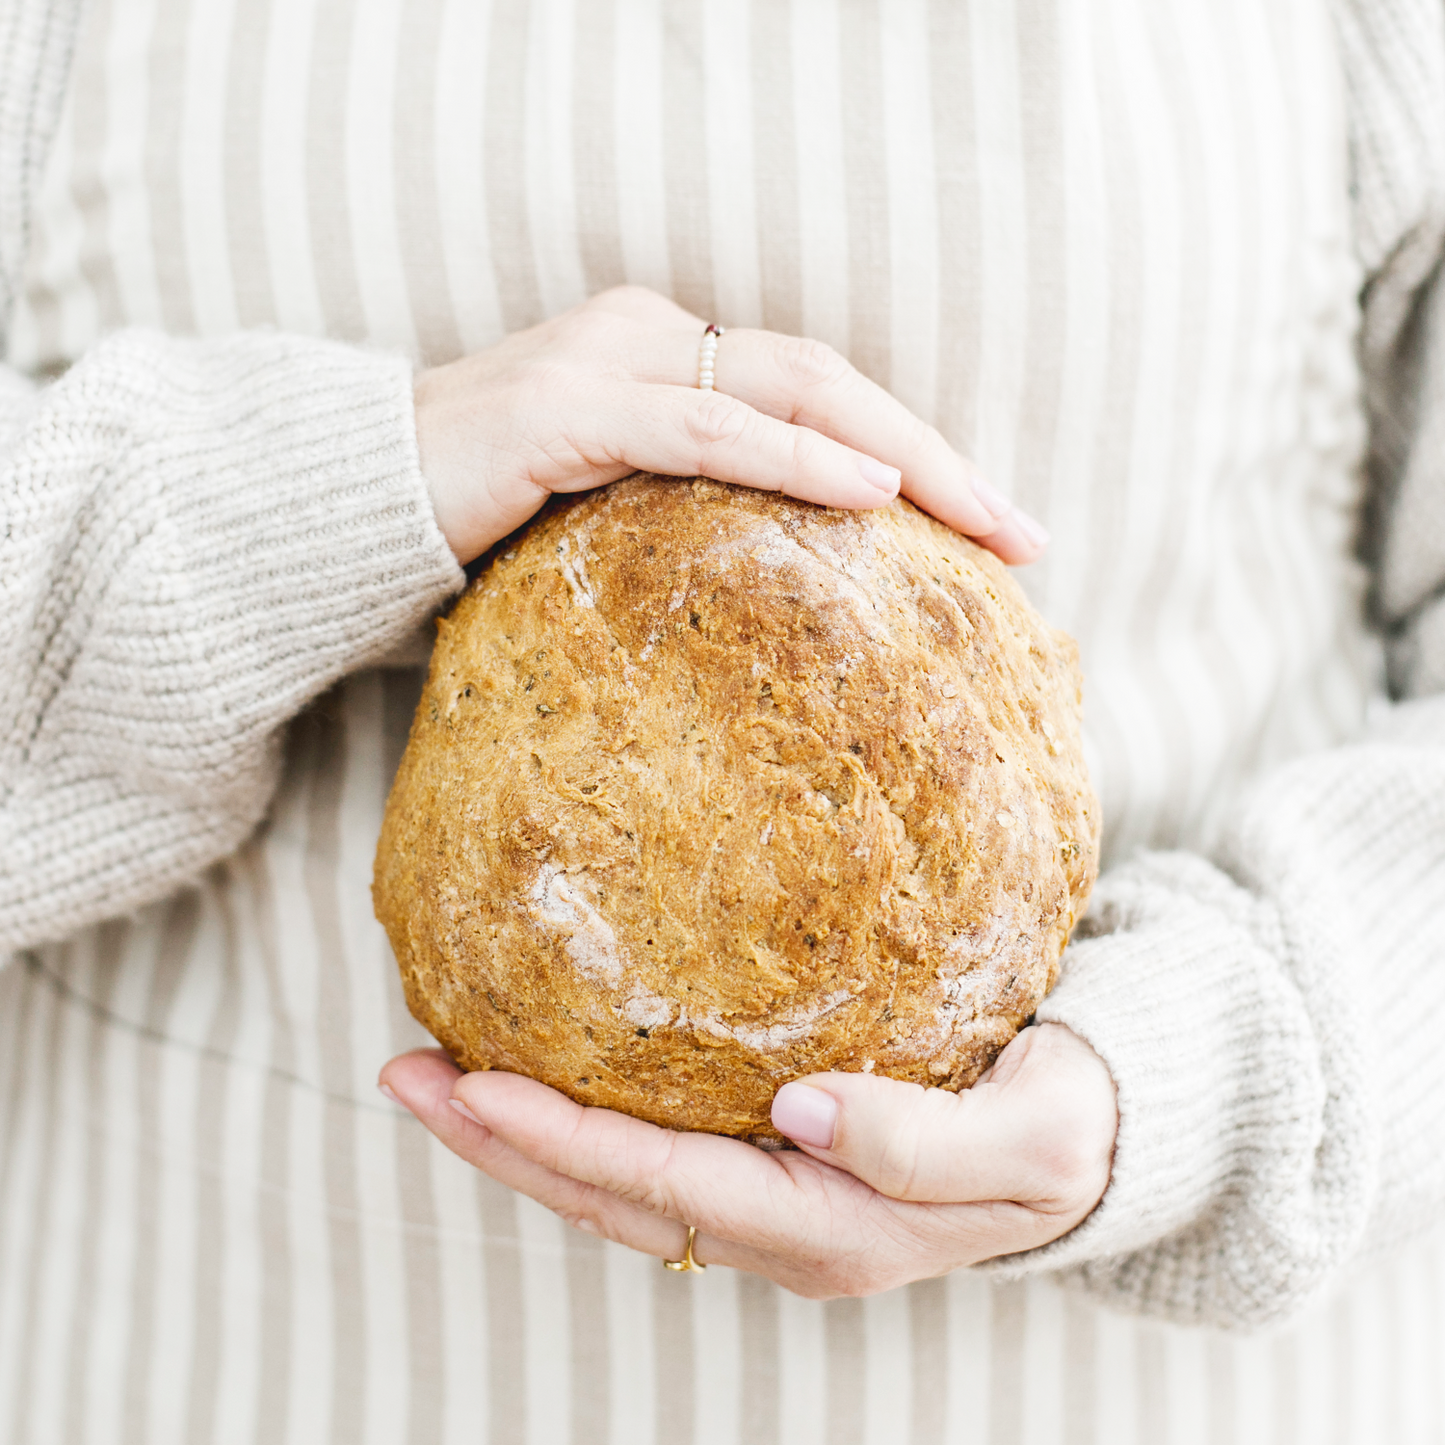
[0, 0, 1445, 1445]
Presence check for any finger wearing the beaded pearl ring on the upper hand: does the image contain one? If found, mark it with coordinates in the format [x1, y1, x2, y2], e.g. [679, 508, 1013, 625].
[629, 327, 1048, 564]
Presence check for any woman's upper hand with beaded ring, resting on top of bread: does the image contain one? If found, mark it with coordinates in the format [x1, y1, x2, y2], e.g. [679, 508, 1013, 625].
[416, 286, 1048, 562]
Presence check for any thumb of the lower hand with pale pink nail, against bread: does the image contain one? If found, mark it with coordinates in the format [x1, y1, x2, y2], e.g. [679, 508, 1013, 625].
[773, 1025, 1118, 1218]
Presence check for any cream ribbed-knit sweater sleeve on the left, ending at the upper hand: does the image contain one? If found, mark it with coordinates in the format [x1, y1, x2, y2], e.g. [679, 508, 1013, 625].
[0, 332, 462, 957]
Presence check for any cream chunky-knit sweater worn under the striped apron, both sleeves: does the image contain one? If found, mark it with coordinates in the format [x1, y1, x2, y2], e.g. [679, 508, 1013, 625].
[0, 0, 1445, 1325]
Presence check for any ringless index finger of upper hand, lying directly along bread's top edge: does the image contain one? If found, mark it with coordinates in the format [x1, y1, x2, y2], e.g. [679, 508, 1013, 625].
[560, 380, 899, 510]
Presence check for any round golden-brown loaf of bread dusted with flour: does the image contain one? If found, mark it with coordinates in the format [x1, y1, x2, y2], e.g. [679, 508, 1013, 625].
[374, 477, 1098, 1143]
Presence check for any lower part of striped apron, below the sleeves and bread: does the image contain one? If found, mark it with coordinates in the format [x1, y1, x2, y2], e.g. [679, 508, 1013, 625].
[8, 669, 1445, 1445]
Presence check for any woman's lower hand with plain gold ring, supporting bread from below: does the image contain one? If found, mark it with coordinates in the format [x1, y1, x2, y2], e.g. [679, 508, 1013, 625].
[381, 1025, 1118, 1299]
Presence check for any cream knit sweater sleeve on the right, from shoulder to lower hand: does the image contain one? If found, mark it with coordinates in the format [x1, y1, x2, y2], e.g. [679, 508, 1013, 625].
[988, 0, 1445, 1328]
